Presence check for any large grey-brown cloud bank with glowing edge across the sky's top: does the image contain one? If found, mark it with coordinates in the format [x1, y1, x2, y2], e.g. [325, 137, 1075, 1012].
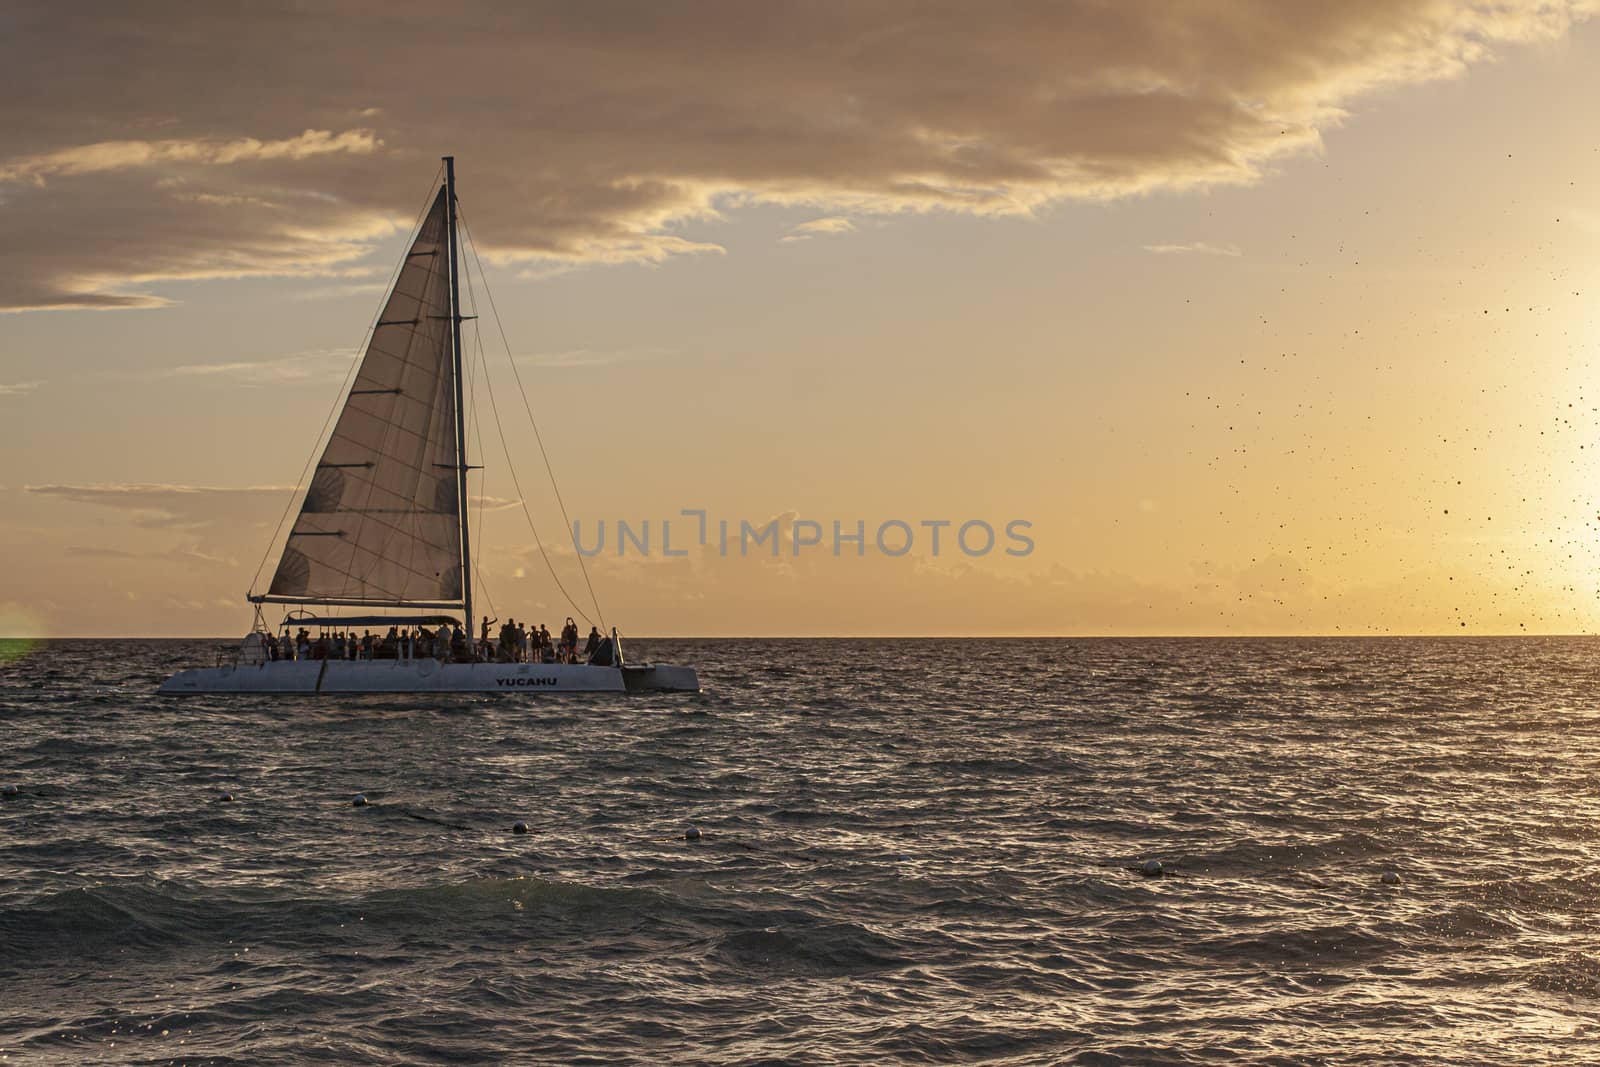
[0, 0, 1592, 310]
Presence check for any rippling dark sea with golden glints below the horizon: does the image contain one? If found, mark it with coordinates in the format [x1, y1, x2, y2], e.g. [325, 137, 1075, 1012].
[0, 638, 1600, 1065]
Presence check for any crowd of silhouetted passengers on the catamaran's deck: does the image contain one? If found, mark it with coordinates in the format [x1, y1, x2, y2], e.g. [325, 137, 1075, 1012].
[252, 616, 611, 665]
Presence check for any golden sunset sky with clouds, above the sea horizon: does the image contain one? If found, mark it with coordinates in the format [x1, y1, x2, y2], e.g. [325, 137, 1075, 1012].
[0, 0, 1600, 635]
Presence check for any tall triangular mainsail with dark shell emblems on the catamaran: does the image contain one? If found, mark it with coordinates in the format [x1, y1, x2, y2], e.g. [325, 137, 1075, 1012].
[258, 189, 464, 606]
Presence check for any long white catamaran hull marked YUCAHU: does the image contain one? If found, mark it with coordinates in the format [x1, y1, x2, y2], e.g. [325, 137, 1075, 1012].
[160, 659, 699, 696]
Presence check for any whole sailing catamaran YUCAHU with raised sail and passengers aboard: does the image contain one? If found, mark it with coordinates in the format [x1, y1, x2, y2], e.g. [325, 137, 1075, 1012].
[160, 155, 699, 696]
